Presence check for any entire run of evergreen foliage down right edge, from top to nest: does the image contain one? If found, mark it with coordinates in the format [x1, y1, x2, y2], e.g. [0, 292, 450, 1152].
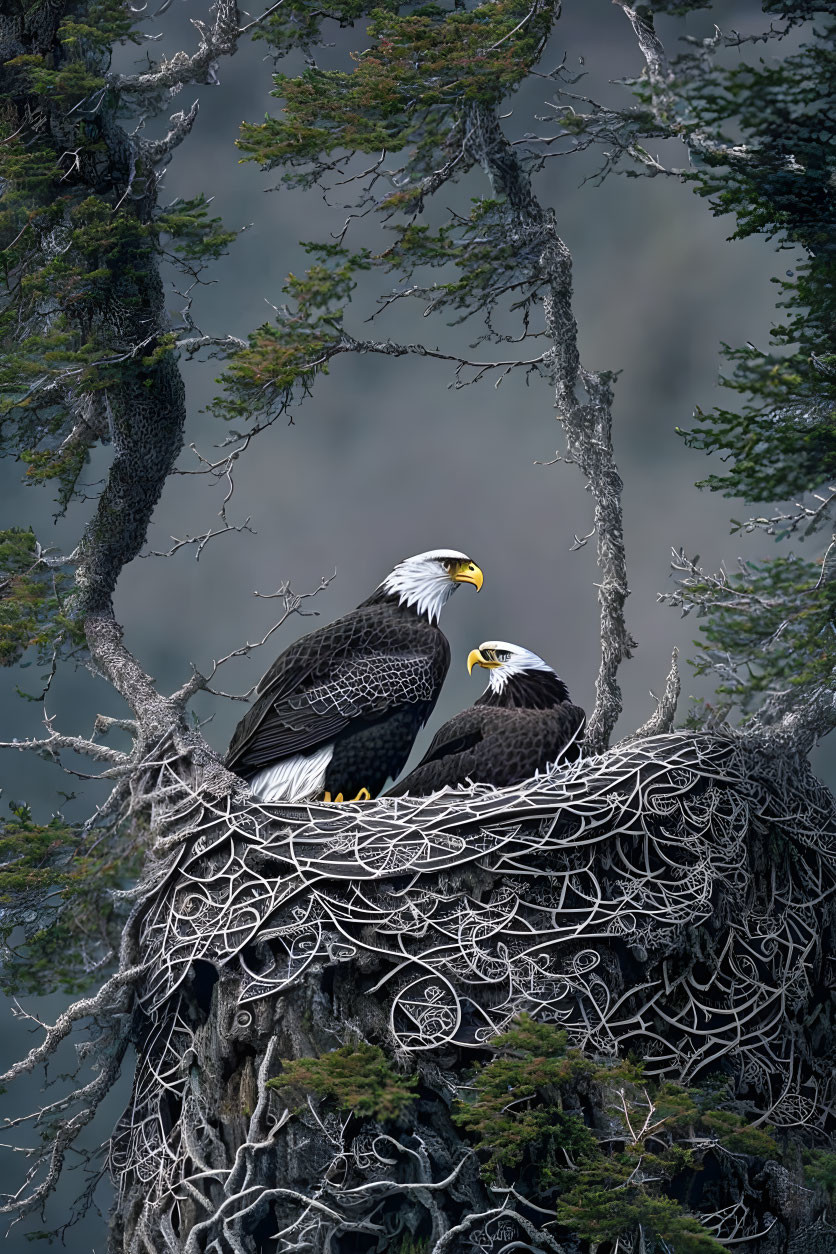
[614, 0, 836, 712]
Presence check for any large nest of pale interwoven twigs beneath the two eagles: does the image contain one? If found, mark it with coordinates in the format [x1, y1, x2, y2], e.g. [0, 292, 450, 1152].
[112, 734, 836, 1249]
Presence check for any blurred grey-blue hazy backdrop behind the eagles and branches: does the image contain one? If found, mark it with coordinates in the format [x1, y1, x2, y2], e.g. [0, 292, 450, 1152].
[0, 0, 836, 1254]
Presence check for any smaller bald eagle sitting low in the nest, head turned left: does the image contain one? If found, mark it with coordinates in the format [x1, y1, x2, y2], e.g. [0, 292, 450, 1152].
[386, 640, 587, 796]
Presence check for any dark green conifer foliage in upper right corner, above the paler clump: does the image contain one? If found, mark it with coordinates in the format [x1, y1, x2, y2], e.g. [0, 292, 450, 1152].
[683, 20, 836, 502]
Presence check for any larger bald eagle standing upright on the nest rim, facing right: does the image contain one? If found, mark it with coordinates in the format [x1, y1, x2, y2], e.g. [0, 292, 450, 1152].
[227, 549, 483, 803]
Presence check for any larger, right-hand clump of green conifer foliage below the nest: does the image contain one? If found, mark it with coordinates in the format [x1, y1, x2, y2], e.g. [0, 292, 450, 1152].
[454, 1014, 777, 1254]
